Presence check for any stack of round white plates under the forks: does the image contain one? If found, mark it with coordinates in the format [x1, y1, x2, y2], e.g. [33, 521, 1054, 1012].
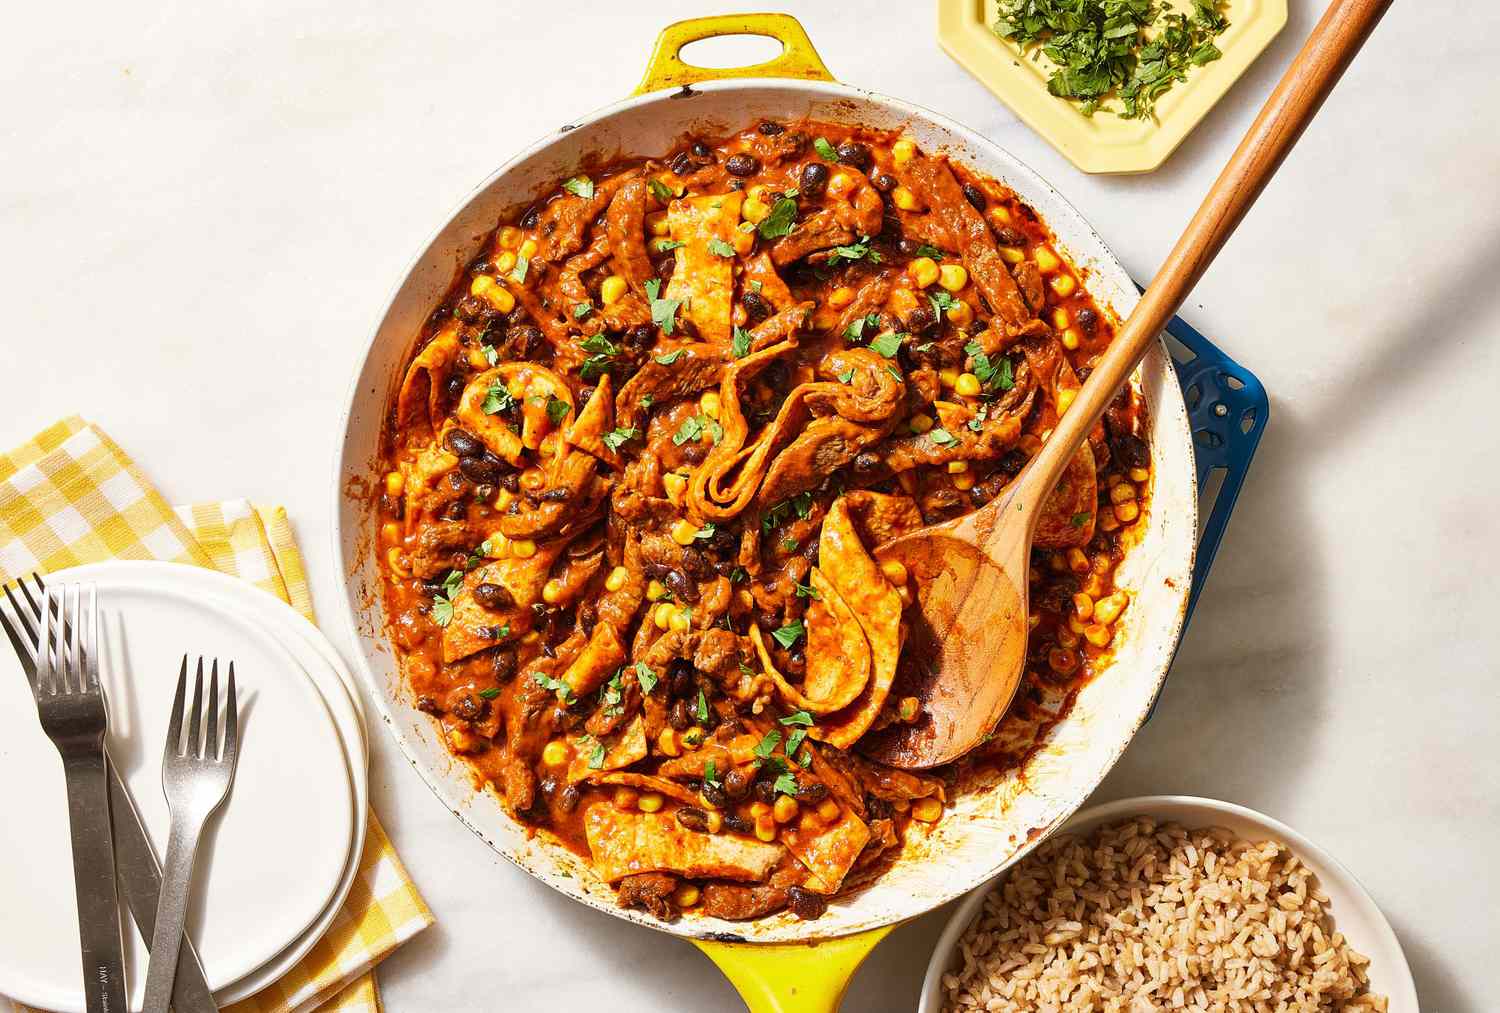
[0, 561, 369, 1011]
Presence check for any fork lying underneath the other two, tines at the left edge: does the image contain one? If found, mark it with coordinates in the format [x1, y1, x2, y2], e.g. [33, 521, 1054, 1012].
[0, 573, 219, 1013]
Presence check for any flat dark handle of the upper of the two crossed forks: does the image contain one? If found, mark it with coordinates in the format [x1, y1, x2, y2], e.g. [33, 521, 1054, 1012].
[63, 747, 129, 1013]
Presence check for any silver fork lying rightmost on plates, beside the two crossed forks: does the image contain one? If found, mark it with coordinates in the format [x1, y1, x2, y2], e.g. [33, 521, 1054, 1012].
[144, 654, 240, 1013]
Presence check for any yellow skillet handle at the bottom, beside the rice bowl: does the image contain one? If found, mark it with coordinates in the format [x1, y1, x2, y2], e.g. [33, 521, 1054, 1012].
[693, 926, 891, 1013]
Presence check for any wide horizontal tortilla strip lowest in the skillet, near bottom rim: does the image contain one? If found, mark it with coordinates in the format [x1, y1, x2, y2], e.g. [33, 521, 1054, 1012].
[584, 801, 785, 882]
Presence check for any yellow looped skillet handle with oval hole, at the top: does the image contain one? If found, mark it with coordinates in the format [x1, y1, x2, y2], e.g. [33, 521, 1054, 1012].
[635, 14, 834, 95]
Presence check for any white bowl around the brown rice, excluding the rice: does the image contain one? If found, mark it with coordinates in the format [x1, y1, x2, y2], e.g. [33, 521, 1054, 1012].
[918, 795, 1418, 1013]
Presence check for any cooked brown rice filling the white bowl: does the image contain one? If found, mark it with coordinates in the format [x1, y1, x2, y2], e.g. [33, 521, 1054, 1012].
[942, 816, 1386, 1013]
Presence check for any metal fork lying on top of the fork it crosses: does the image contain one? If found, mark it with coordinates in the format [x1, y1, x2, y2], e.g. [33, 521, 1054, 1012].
[33, 584, 129, 1013]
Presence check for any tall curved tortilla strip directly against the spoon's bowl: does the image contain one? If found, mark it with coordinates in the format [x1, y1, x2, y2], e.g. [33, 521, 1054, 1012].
[807, 497, 902, 749]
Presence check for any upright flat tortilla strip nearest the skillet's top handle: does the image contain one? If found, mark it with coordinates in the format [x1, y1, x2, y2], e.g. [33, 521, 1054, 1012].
[662, 191, 744, 342]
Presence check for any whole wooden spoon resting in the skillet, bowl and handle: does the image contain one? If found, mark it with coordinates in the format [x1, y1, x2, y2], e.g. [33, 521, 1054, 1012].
[861, 0, 1391, 768]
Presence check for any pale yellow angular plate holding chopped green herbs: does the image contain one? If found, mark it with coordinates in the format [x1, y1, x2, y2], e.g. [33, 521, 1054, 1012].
[938, 0, 1287, 173]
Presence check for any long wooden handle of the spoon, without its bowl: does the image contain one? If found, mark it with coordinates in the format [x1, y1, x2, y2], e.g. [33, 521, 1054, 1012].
[1016, 0, 1392, 504]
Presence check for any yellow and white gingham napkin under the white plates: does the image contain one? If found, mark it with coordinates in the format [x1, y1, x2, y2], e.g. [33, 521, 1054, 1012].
[0, 417, 432, 1013]
